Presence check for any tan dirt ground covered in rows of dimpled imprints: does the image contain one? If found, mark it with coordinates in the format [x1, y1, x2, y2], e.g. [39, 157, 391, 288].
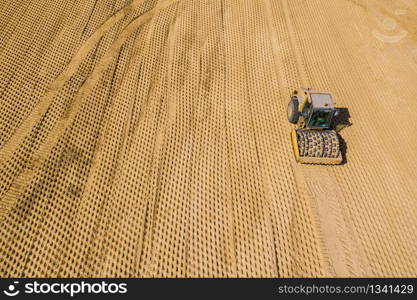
[0, 0, 417, 277]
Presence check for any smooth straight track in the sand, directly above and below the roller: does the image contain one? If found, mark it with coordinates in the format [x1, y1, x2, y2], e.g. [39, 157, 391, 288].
[282, 0, 364, 277]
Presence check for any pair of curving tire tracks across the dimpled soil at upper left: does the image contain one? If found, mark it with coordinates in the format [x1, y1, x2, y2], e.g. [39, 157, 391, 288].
[0, 0, 179, 225]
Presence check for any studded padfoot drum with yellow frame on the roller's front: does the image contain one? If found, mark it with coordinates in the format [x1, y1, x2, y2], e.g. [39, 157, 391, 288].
[291, 129, 342, 165]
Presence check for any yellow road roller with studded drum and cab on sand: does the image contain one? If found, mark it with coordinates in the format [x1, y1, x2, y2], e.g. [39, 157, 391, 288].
[287, 88, 343, 165]
